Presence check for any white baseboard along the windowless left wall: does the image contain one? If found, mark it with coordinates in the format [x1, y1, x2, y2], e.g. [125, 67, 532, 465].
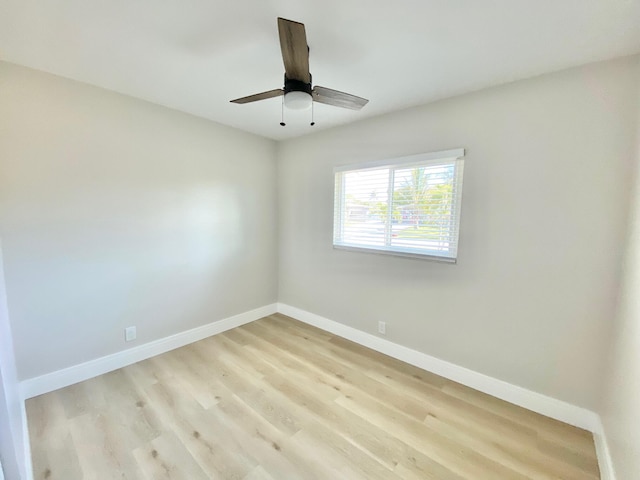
[20, 303, 277, 399]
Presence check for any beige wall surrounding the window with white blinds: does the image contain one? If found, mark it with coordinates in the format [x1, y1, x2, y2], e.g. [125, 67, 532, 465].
[278, 57, 639, 409]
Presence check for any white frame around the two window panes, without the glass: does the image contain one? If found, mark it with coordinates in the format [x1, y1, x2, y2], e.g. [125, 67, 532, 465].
[333, 148, 465, 263]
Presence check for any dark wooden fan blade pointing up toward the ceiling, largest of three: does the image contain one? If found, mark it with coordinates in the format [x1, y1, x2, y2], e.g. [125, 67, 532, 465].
[278, 18, 311, 83]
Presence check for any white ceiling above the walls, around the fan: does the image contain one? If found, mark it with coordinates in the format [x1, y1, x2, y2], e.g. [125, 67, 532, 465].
[0, 0, 640, 139]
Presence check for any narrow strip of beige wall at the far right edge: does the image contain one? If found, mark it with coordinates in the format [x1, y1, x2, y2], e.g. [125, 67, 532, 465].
[601, 67, 640, 480]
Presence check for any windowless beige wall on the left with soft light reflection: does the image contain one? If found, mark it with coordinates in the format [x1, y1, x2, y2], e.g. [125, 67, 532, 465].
[0, 63, 277, 379]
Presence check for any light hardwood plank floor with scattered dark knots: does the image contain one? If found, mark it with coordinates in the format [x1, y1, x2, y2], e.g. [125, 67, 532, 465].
[27, 314, 600, 480]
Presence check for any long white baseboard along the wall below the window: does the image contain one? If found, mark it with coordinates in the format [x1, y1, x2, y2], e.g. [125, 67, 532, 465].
[278, 303, 602, 432]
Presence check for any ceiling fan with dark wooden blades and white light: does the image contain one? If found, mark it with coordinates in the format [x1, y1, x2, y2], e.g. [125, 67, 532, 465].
[231, 18, 369, 118]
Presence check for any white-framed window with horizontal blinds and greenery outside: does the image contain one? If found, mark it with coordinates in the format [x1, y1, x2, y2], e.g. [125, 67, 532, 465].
[333, 149, 464, 262]
